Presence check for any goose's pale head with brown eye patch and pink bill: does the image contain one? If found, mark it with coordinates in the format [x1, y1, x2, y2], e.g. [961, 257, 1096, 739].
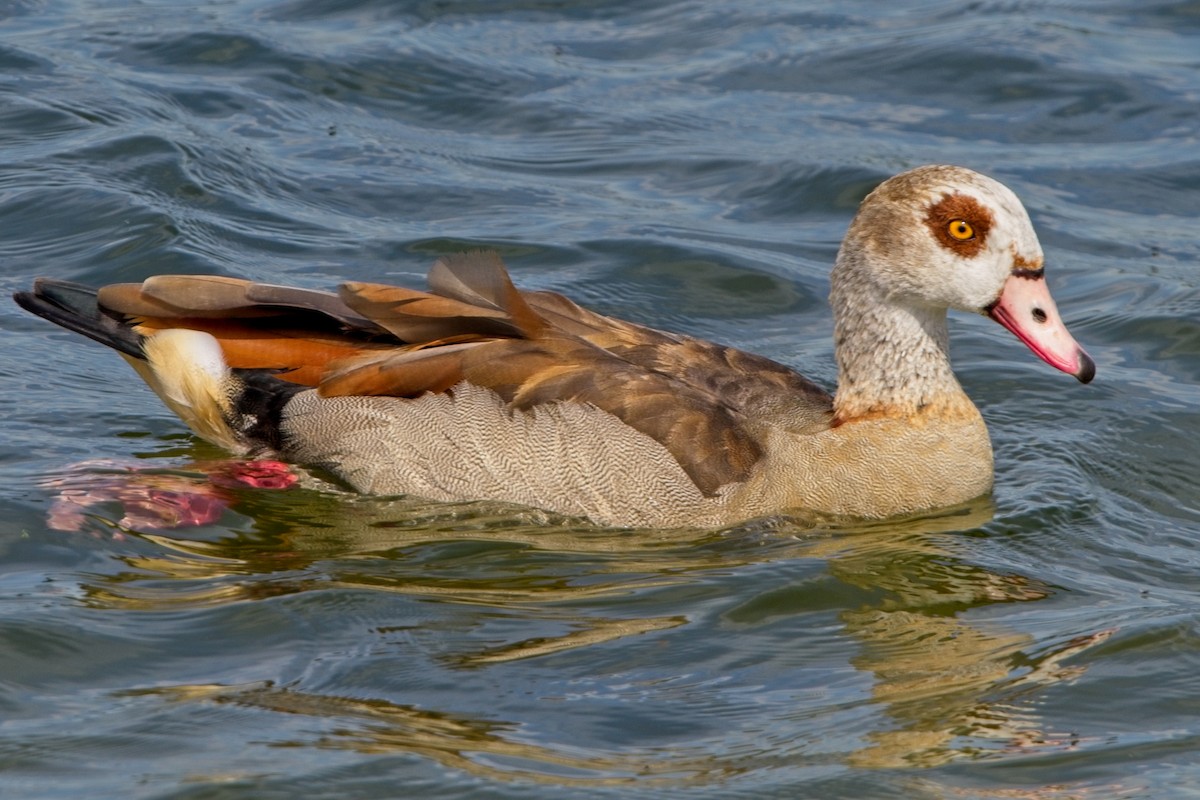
[832, 166, 1096, 383]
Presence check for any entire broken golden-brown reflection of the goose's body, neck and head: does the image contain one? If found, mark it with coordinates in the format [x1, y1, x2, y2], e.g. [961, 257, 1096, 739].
[46, 455, 1109, 786]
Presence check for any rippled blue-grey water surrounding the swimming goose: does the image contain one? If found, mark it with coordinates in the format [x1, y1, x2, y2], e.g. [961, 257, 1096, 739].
[0, 0, 1200, 799]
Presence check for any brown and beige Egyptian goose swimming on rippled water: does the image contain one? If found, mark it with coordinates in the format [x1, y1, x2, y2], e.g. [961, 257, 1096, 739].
[14, 166, 1096, 528]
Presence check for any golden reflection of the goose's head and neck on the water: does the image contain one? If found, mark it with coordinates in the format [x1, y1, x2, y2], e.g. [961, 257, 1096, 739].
[829, 536, 1110, 768]
